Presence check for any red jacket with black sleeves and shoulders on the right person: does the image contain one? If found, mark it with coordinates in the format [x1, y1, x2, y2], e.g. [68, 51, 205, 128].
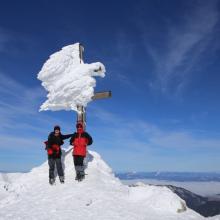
[70, 132, 92, 157]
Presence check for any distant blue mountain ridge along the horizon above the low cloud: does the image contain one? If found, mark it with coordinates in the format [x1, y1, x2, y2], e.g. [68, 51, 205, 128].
[116, 172, 220, 182]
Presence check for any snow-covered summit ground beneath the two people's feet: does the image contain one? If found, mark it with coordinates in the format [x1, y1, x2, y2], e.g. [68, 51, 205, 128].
[0, 150, 208, 220]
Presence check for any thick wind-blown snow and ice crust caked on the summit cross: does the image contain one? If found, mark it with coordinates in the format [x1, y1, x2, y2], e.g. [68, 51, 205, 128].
[37, 43, 105, 111]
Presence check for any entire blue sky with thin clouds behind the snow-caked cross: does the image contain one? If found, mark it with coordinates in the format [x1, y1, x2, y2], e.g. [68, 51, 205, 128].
[0, 0, 220, 171]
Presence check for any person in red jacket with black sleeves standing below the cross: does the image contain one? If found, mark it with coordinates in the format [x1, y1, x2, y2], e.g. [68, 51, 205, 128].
[70, 122, 93, 181]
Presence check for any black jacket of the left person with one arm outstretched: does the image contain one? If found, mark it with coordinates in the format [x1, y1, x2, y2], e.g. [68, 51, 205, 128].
[47, 132, 73, 158]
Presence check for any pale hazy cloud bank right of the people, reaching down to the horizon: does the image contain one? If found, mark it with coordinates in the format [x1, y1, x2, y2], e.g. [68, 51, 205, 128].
[88, 107, 220, 171]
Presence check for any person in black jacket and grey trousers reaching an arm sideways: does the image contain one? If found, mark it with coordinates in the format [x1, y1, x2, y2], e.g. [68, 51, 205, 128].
[46, 125, 73, 185]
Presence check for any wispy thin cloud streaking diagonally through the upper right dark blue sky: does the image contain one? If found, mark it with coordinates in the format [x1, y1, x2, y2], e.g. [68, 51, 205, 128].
[143, 1, 219, 95]
